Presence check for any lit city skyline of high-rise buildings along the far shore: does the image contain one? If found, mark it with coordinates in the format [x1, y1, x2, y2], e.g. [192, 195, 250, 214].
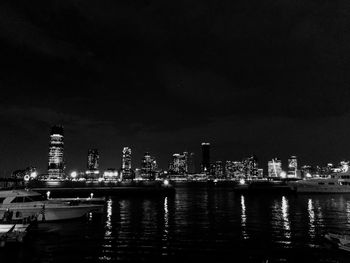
[2, 125, 346, 179]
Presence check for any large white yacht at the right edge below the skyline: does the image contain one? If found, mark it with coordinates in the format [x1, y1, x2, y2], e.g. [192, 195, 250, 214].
[289, 172, 350, 194]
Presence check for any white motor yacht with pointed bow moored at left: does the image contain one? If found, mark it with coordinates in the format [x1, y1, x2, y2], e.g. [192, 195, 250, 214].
[0, 190, 103, 222]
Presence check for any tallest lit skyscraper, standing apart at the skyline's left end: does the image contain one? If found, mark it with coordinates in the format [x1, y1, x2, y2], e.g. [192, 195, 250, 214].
[47, 126, 65, 179]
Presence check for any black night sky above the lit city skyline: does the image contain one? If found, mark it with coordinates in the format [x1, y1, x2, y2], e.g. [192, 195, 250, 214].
[0, 0, 350, 176]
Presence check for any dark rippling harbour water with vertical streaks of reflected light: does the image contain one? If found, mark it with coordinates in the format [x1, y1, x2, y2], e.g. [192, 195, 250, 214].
[0, 187, 350, 263]
